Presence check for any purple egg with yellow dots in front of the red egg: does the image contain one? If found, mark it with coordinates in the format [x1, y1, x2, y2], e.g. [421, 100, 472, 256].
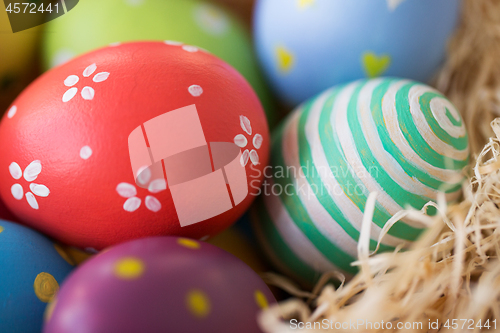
[43, 237, 276, 333]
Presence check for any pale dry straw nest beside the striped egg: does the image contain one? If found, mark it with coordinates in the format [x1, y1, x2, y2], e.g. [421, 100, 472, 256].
[259, 0, 500, 333]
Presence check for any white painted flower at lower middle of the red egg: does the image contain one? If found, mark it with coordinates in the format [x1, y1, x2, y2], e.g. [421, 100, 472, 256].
[116, 169, 167, 213]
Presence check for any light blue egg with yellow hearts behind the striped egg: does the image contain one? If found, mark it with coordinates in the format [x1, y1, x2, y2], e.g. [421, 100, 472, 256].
[254, 0, 461, 106]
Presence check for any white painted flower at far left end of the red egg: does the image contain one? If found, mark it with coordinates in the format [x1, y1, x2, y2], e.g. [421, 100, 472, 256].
[9, 160, 50, 209]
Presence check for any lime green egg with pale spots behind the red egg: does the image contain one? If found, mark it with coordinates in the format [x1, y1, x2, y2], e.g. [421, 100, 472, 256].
[43, 0, 276, 123]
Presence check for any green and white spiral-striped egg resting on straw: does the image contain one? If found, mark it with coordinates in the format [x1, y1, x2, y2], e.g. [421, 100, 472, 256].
[253, 79, 469, 283]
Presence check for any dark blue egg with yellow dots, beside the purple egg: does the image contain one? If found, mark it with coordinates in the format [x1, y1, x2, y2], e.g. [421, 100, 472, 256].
[0, 220, 73, 333]
